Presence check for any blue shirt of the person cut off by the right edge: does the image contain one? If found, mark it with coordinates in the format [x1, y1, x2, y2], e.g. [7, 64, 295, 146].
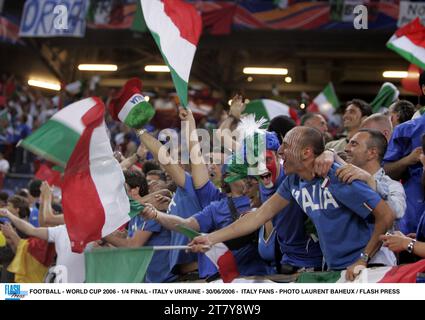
[384, 115, 425, 234]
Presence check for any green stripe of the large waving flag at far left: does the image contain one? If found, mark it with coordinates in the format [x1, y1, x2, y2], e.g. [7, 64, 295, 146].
[19, 119, 80, 167]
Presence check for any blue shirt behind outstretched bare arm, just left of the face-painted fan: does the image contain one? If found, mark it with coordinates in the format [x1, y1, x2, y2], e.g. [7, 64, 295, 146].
[193, 196, 269, 276]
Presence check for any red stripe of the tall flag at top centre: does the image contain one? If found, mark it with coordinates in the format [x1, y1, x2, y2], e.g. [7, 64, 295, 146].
[162, 0, 202, 46]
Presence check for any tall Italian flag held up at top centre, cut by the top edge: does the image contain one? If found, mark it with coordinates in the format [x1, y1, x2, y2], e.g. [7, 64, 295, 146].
[140, 0, 202, 107]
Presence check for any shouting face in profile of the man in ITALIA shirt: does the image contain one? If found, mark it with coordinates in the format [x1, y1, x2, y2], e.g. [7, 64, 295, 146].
[278, 128, 302, 175]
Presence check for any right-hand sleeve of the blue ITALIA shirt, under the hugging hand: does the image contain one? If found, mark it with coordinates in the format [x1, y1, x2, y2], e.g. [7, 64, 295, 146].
[328, 173, 381, 219]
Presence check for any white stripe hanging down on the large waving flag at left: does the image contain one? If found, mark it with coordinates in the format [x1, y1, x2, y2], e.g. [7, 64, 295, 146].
[89, 122, 130, 237]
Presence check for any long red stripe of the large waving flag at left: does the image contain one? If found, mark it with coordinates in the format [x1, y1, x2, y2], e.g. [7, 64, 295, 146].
[62, 98, 105, 253]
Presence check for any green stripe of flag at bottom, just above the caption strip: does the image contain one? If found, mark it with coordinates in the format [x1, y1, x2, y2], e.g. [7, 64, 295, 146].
[85, 247, 154, 283]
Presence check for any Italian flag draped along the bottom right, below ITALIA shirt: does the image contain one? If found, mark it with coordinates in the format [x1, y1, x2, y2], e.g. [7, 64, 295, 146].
[297, 259, 425, 283]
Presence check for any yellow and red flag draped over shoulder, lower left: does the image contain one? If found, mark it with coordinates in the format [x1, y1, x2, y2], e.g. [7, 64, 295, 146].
[7, 238, 56, 283]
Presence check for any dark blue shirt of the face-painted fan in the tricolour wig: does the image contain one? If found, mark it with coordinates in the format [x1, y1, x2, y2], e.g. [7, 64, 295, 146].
[260, 166, 323, 268]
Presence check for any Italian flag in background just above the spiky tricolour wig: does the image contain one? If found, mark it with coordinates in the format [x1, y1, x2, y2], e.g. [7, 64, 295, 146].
[245, 99, 298, 122]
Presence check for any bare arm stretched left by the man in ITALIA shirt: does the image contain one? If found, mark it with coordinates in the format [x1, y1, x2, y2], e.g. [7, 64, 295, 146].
[189, 193, 289, 252]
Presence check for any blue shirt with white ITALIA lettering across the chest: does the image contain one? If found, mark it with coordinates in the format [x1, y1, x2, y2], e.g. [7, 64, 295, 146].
[278, 163, 381, 270]
